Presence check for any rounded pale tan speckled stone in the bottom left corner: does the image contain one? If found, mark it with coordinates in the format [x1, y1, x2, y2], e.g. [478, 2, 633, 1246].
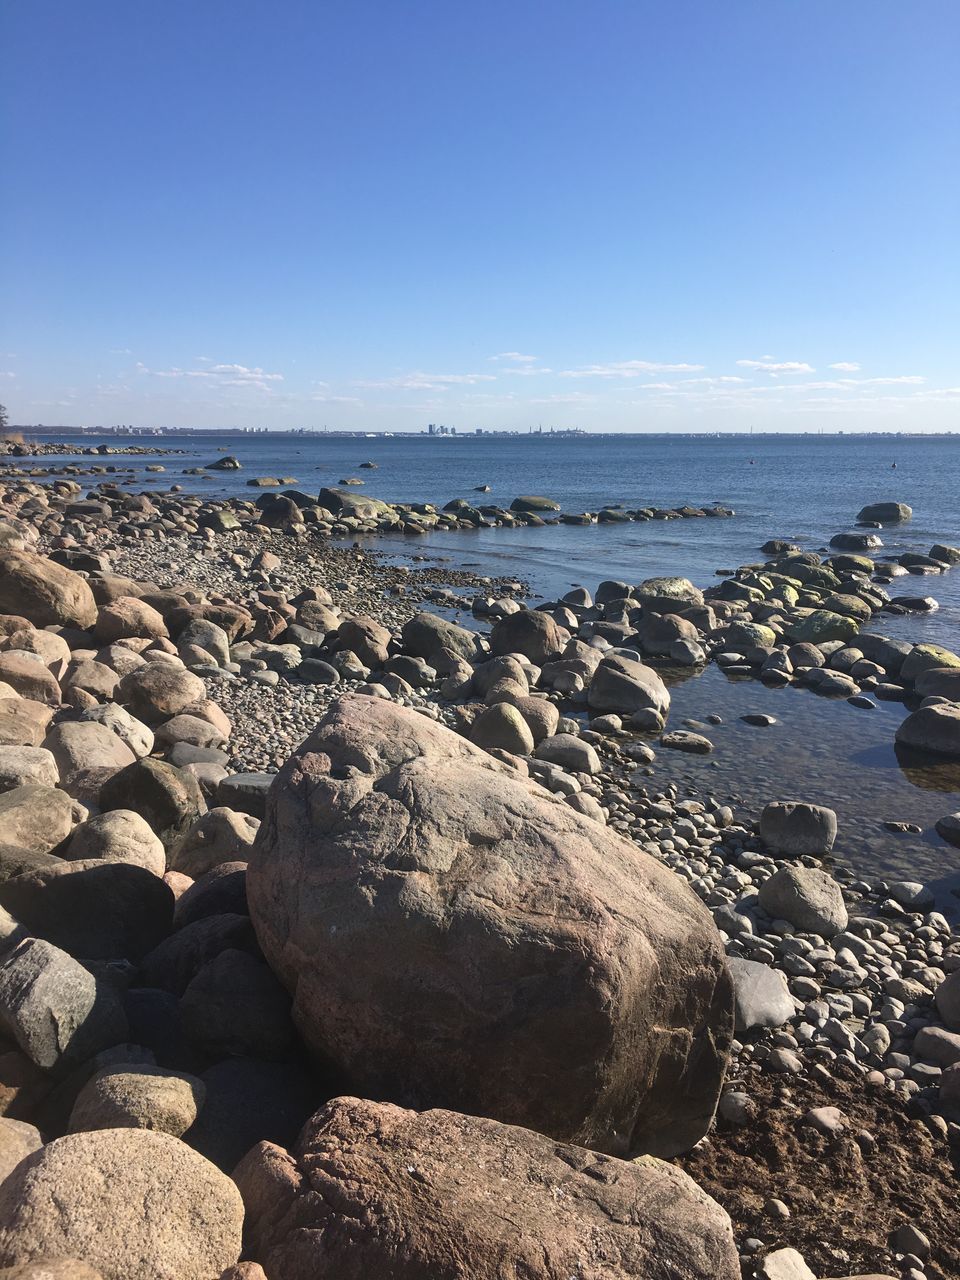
[0, 1129, 243, 1280]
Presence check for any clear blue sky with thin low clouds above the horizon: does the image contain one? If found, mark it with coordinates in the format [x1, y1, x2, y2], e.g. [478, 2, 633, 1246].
[0, 0, 960, 431]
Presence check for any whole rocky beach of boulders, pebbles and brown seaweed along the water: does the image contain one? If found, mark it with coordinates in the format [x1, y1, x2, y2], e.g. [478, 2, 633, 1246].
[0, 471, 960, 1280]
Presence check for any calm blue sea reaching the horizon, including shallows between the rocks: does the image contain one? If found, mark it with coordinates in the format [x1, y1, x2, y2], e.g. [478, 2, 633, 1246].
[13, 433, 960, 901]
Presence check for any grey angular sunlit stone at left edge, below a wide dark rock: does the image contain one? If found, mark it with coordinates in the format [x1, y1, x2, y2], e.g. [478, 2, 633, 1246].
[0, 938, 127, 1070]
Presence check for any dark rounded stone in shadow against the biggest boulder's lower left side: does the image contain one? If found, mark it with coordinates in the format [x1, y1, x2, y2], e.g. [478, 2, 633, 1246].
[180, 948, 293, 1059]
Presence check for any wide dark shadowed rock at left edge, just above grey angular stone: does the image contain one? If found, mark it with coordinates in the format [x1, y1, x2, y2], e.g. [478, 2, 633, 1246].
[0, 859, 174, 961]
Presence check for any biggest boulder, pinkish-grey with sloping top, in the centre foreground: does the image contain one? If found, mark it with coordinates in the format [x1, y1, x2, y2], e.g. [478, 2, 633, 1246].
[247, 696, 732, 1155]
